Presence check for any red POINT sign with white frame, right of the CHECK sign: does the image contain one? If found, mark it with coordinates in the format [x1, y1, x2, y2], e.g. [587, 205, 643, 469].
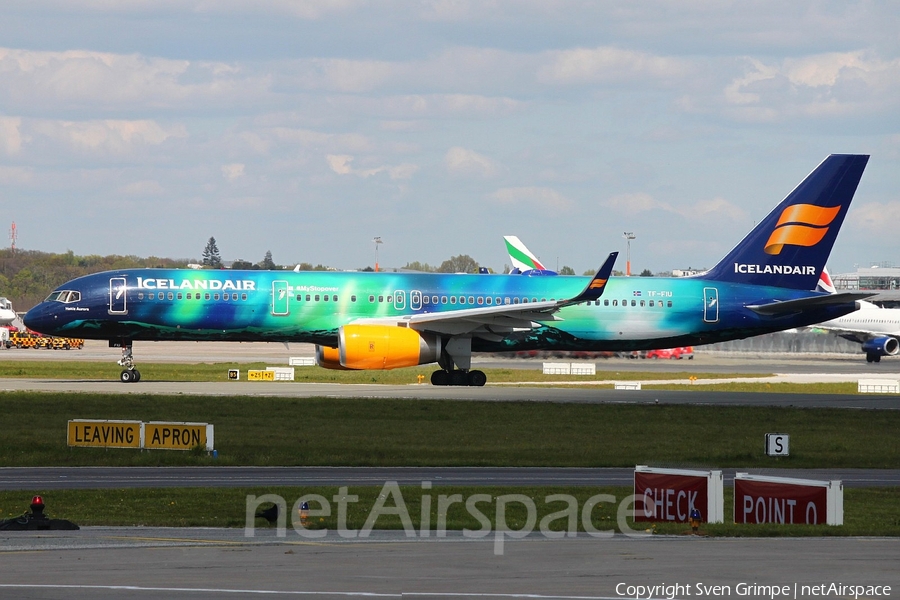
[734, 473, 844, 525]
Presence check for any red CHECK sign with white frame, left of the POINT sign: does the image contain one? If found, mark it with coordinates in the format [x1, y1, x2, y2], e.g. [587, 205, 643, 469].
[634, 465, 724, 523]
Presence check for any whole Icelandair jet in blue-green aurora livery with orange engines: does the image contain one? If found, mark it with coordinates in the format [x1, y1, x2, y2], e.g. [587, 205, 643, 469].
[25, 155, 869, 386]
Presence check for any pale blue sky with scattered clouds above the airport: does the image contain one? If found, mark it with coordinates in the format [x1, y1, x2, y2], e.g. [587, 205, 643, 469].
[0, 0, 900, 273]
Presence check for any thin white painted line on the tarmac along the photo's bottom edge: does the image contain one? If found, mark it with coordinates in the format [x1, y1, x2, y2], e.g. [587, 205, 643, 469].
[0, 583, 663, 600]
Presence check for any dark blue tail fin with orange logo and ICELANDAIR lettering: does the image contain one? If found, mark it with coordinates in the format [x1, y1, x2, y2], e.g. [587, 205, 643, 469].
[703, 154, 869, 290]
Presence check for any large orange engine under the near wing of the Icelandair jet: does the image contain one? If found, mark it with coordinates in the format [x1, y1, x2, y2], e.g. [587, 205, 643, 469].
[338, 325, 441, 370]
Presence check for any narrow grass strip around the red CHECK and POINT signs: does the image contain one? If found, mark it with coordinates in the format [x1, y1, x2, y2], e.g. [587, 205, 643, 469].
[0, 486, 900, 541]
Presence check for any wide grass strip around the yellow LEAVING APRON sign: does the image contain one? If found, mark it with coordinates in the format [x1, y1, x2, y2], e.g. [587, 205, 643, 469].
[0, 392, 900, 468]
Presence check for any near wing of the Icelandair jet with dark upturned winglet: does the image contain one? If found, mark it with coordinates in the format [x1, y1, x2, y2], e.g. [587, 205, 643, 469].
[348, 252, 619, 340]
